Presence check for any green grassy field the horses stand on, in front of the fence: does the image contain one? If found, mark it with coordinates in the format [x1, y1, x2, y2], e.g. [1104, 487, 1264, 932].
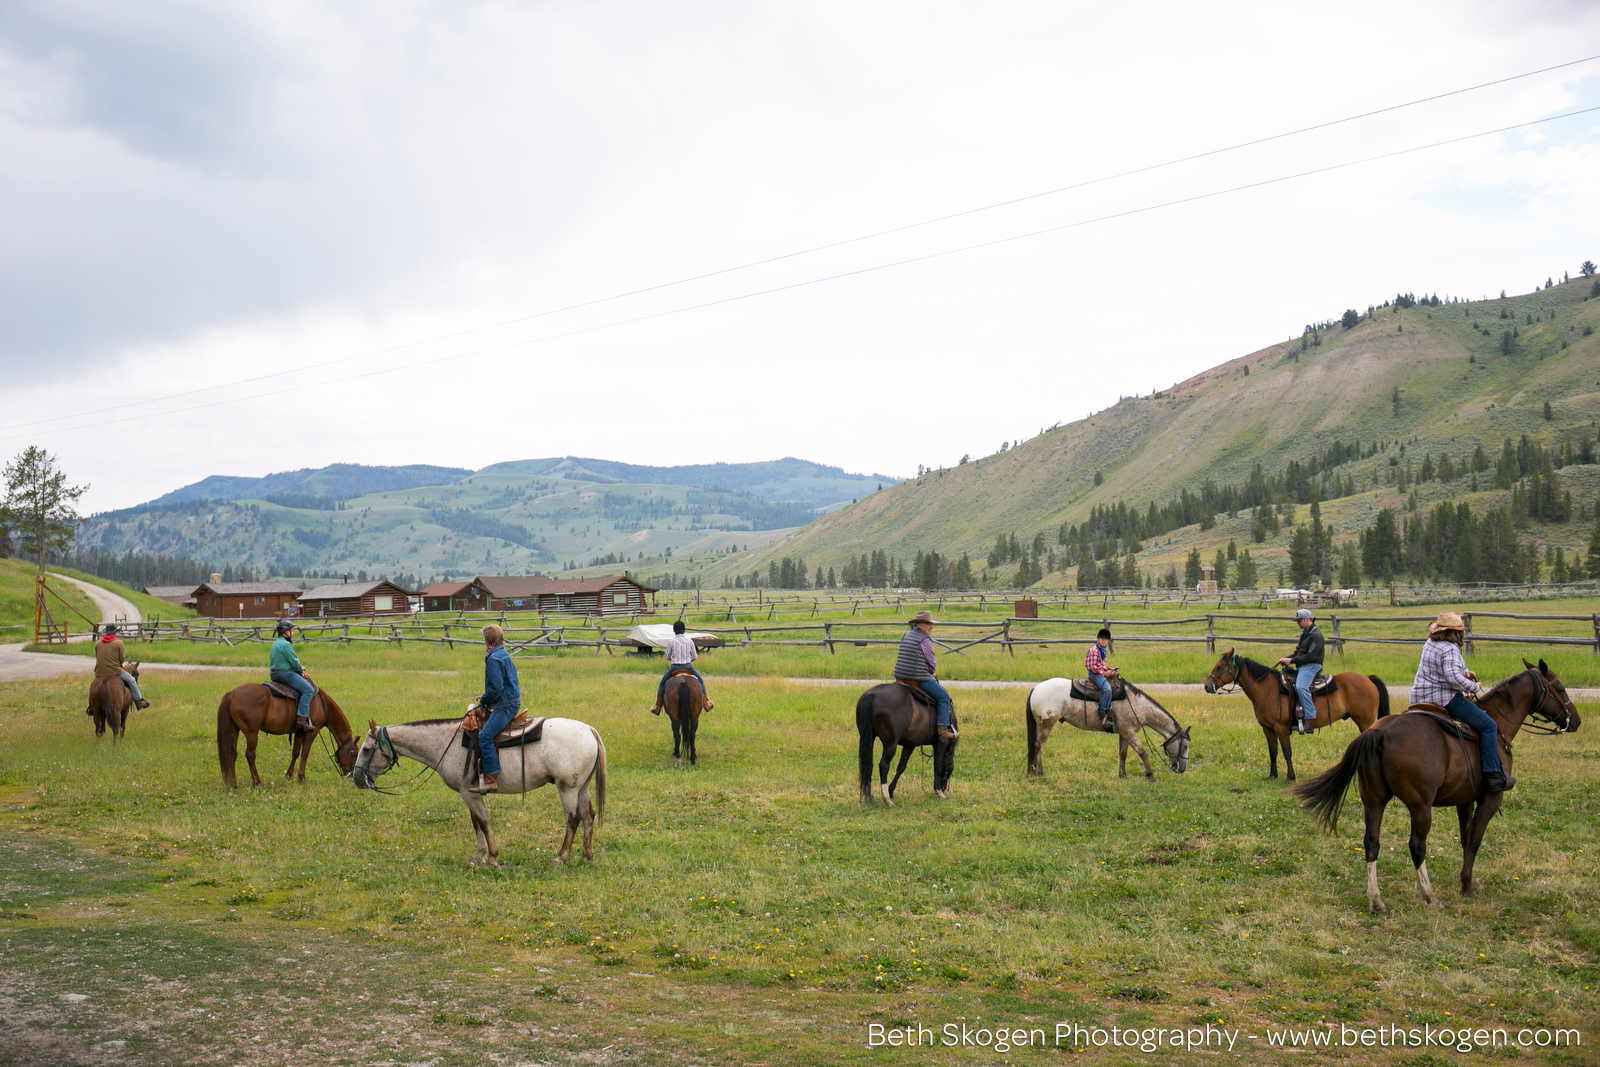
[0, 649, 1600, 1064]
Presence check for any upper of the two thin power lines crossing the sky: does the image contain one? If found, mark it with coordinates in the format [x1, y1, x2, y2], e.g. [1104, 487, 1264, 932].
[0, 54, 1600, 440]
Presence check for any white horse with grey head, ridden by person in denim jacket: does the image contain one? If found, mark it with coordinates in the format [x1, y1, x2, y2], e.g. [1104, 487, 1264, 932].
[350, 718, 605, 867]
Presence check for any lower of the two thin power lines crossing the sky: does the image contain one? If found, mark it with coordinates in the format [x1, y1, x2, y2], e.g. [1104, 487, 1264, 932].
[0, 106, 1600, 442]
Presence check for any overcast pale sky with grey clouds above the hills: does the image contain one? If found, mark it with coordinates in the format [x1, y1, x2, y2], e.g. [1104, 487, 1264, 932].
[0, 0, 1600, 510]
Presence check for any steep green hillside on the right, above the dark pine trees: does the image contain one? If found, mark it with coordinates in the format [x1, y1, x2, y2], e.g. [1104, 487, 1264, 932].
[672, 278, 1600, 587]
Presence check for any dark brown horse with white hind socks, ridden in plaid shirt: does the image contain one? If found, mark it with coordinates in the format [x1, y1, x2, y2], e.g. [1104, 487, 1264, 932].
[1294, 659, 1582, 912]
